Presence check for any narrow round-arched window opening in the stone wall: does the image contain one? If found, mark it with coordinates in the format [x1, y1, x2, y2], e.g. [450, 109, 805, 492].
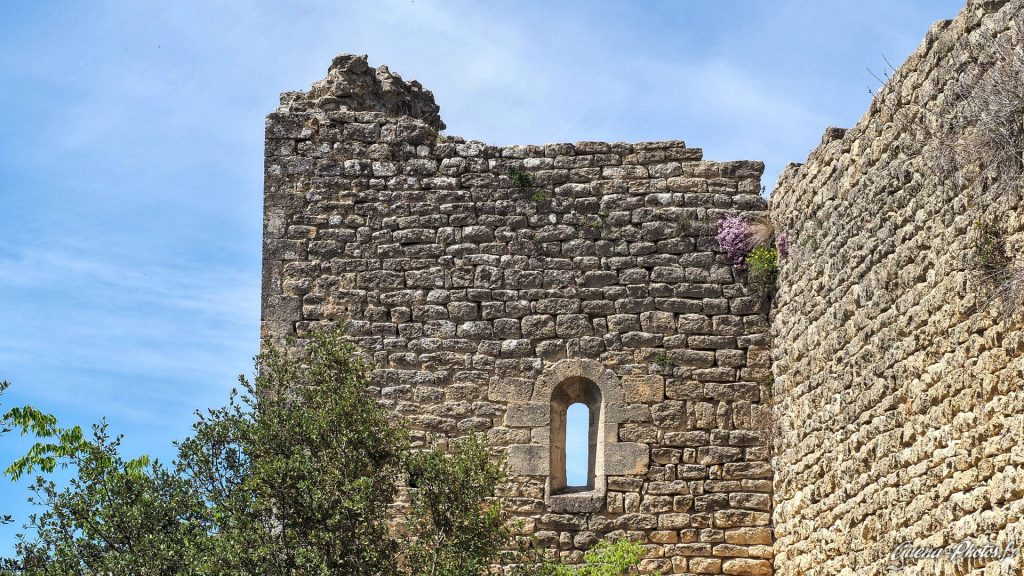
[550, 378, 601, 494]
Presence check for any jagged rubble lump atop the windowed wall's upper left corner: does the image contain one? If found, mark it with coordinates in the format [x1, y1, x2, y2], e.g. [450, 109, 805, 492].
[278, 54, 444, 130]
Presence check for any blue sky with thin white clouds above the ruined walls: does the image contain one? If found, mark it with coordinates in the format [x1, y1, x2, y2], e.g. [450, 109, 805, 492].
[0, 0, 962, 556]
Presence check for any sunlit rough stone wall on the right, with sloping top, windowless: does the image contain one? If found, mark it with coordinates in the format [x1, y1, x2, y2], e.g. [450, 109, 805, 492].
[771, 0, 1024, 575]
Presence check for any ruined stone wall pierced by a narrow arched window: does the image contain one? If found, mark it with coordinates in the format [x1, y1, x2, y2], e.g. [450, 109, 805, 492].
[263, 56, 772, 574]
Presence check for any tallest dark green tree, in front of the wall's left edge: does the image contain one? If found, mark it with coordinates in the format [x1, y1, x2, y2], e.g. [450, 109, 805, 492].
[178, 325, 409, 575]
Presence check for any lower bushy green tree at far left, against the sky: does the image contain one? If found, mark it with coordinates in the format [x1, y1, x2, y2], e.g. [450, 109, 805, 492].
[16, 422, 209, 576]
